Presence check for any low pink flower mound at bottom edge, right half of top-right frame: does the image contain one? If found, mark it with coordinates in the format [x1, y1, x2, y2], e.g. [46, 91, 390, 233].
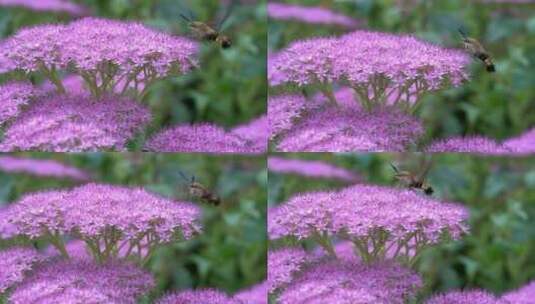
[426, 136, 508, 154]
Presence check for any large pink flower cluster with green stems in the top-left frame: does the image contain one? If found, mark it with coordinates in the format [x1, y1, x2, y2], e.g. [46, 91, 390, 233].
[0, 18, 197, 97]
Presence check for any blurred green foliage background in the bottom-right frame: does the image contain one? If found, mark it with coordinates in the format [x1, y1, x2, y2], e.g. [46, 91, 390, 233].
[268, 153, 535, 298]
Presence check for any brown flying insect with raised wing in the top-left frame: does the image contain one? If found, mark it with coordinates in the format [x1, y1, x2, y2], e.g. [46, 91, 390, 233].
[180, 1, 236, 49]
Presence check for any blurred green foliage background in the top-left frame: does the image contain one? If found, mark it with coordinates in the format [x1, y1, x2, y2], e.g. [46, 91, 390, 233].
[0, 0, 267, 140]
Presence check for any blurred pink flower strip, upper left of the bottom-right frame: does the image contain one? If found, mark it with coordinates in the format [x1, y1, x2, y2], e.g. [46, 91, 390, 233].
[268, 156, 359, 182]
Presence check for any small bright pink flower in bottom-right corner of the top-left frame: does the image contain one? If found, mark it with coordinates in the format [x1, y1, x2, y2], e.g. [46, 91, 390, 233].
[231, 115, 269, 153]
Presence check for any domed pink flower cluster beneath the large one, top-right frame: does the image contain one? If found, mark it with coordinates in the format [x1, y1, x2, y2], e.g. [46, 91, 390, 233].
[276, 106, 423, 152]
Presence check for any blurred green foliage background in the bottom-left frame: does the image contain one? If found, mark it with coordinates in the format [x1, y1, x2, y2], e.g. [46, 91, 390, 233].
[0, 153, 267, 298]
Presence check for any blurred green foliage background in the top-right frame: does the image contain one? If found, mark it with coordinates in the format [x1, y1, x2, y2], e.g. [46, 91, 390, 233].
[268, 0, 535, 145]
